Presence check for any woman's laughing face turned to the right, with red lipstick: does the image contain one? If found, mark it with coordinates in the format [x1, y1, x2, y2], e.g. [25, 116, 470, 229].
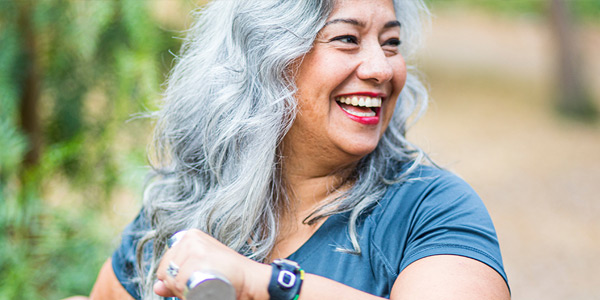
[284, 0, 406, 166]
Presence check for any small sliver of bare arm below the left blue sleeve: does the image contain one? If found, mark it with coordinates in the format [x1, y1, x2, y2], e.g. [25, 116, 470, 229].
[90, 258, 133, 300]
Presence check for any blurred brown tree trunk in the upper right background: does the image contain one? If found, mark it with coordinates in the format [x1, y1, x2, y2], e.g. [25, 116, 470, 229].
[550, 0, 597, 120]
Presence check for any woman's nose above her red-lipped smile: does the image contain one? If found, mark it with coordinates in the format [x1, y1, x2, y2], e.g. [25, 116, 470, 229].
[356, 44, 394, 84]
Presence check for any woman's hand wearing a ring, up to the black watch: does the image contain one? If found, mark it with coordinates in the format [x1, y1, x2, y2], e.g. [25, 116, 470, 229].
[154, 229, 270, 299]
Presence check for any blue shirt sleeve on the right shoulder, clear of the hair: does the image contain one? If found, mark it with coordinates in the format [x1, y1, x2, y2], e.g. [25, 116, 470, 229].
[378, 169, 507, 281]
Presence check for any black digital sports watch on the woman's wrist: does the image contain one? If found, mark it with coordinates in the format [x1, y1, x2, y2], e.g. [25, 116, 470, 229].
[269, 259, 304, 300]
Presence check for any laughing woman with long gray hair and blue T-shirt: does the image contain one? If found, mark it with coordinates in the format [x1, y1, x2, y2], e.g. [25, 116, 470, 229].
[92, 0, 510, 299]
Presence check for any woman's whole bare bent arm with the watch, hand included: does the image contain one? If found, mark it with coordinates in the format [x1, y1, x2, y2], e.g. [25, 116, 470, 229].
[154, 230, 510, 300]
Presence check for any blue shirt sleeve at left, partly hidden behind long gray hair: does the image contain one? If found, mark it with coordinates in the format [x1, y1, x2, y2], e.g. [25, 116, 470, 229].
[112, 212, 150, 299]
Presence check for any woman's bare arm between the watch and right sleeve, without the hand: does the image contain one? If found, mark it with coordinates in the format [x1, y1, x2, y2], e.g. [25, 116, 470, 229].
[261, 255, 510, 300]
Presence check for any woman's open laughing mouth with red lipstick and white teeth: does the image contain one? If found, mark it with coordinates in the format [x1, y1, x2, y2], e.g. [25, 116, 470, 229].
[335, 95, 382, 125]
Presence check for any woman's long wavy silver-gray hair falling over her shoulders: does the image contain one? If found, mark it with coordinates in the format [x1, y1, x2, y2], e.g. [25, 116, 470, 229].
[137, 0, 427, 298]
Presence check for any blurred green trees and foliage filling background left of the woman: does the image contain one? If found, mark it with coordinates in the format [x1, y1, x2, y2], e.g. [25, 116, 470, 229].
[0, 0, 179, 299]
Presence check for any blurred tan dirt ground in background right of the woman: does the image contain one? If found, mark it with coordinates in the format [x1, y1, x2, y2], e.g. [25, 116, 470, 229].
[410, 10, 600, 300]
